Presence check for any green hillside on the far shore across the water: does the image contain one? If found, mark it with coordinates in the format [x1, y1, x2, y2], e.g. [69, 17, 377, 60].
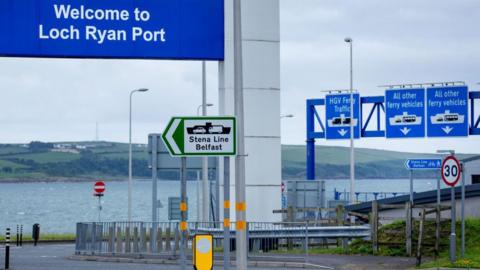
[0, 141, 474, 181]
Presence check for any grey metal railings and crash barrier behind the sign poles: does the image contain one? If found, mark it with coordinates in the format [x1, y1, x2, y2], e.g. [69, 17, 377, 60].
[75, 222, 370, 260]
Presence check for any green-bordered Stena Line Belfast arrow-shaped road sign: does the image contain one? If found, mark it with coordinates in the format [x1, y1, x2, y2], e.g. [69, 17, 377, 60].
[162, 116, 237, 156]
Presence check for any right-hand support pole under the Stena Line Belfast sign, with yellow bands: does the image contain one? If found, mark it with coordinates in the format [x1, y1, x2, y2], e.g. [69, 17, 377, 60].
[223, 157, 230, 270]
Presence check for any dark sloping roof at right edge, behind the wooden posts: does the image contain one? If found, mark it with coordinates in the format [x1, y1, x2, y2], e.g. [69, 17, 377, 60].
[345, 184, 480, 213]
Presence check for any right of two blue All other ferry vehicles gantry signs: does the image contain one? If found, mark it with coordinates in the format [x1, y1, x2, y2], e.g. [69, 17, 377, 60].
[427, 86, 468, 137]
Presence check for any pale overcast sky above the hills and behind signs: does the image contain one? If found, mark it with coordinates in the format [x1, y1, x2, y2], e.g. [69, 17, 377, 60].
[0, 0, 480, 153]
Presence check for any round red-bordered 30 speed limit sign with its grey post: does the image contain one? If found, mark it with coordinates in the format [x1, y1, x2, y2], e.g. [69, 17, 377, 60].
[442, 155, 462, 263]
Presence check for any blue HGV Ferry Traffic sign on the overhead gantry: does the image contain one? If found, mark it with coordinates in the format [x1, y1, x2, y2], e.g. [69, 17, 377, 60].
[325, 94, 361, 139]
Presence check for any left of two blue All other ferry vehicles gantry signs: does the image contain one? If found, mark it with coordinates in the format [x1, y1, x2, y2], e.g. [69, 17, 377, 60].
[385, 88, 425, 138]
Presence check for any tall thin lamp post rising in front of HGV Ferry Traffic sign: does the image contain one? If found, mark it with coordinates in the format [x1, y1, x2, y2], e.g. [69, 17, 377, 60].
[345, 37, 355, 223]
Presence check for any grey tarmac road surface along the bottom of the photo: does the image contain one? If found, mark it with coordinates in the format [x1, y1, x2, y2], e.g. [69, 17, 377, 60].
[0, 244, 450, 270]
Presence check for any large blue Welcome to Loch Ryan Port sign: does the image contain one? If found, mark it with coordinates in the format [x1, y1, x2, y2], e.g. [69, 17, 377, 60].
[0, 0, 224, 60]
